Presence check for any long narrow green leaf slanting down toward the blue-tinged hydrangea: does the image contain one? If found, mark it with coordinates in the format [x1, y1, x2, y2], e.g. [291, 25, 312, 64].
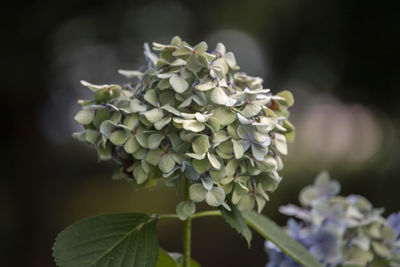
[243, 211, 322, 267]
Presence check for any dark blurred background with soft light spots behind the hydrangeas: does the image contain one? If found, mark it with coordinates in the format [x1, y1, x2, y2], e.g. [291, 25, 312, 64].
[0, 0, 400, 267]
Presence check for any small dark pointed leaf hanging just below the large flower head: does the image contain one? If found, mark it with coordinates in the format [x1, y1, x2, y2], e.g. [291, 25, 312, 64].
[221, 205, 252, 248]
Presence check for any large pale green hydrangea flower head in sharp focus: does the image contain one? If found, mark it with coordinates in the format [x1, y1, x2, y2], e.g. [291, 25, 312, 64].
[74, 37, 294, 219]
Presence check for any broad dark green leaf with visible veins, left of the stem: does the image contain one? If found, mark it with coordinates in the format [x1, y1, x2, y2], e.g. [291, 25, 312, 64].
[53, 214, 158, 267]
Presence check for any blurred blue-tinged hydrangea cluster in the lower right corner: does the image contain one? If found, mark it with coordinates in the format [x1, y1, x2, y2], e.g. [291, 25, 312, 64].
[265, 172, 400, 267]
